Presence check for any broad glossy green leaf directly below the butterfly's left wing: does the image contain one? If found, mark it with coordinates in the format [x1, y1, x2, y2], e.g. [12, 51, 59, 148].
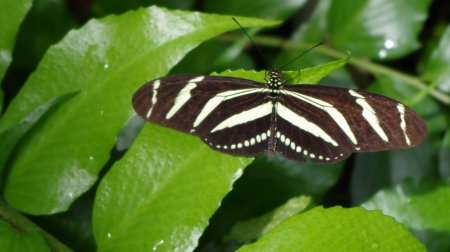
[93, 124, 252, 251]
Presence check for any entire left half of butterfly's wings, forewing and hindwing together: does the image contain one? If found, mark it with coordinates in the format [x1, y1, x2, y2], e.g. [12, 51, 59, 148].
[132, 75, 272, 156]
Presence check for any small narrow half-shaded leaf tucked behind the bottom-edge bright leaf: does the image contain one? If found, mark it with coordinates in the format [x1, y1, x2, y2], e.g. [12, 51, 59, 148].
[224, 196, 314, 243]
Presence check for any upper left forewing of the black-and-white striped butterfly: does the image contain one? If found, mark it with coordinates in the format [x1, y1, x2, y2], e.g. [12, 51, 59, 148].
[132, 75, 261, 135]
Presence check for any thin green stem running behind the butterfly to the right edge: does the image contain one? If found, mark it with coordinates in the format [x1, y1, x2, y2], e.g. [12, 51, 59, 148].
[219, 34, 450, 104]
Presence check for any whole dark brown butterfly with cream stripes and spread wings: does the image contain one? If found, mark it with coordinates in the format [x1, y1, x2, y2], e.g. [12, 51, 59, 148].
[133, 69, 427, 164]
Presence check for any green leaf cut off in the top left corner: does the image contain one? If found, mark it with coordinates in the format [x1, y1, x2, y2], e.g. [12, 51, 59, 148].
[0, 0, 33, 79]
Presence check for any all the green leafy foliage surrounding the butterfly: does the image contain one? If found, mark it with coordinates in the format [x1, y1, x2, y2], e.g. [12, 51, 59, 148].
[0, 0, 450, 251]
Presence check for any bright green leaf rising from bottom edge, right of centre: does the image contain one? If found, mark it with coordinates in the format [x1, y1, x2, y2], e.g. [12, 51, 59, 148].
[238, 207, 426, 251]
